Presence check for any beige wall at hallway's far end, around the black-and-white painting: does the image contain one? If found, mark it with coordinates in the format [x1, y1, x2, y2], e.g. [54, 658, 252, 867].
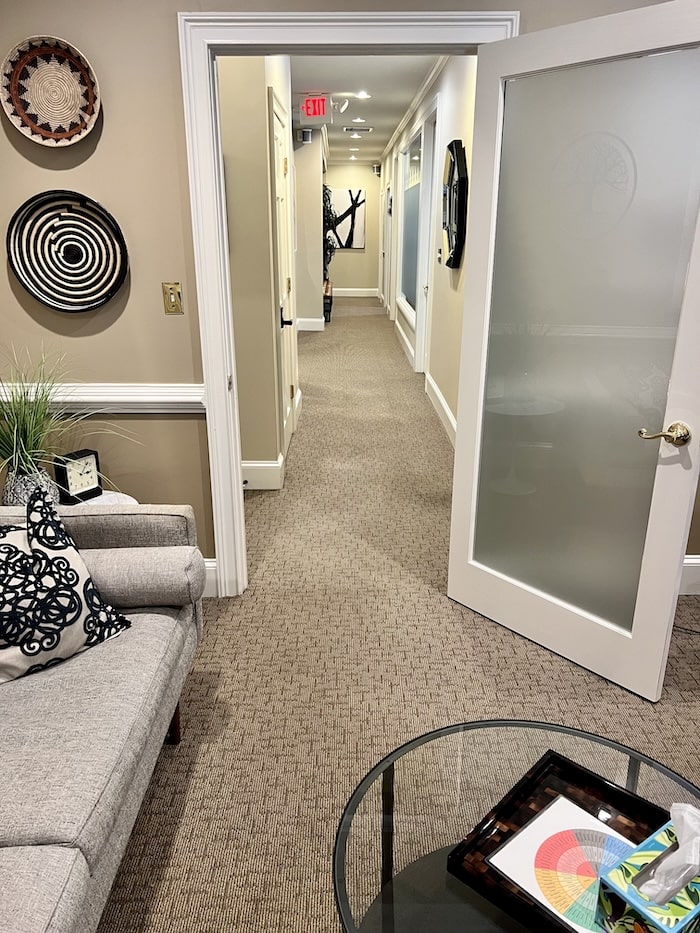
[323, 163, 379, 289]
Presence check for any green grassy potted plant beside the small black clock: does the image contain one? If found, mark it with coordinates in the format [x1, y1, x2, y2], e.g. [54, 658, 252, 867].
[0, 352, 95, 505]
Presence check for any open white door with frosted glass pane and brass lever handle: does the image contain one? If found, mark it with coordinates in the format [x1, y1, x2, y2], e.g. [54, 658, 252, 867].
[448, 0, 700, 700]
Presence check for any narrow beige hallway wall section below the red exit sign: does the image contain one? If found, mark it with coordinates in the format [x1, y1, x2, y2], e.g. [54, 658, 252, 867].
[294, 130, 323, 321]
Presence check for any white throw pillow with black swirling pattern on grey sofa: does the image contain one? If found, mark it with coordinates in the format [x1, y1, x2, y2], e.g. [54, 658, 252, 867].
[0, 489, 131, 683]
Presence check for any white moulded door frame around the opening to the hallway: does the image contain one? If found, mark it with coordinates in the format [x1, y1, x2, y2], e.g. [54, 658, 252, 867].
[178, 12, 519, 596]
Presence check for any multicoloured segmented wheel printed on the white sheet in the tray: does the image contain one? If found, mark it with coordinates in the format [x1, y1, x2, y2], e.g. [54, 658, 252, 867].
[535, 829, 633, 930]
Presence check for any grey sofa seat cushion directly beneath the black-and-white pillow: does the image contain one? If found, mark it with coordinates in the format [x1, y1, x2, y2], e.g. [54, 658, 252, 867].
[0, 607, 189, 872]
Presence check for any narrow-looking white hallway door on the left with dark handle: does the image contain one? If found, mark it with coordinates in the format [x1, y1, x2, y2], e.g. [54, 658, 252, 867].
[268, 88, 298, 457]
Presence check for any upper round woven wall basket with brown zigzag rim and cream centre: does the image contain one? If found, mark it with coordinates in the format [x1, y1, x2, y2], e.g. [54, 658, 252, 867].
[0, 36, 100, 146]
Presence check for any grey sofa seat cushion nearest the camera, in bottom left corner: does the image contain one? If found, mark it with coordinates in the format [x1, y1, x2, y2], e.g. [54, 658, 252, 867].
[0, 846, 90, 933]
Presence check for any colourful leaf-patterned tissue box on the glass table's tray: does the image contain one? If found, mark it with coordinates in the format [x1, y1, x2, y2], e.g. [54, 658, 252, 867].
[596, 823, 700, 933]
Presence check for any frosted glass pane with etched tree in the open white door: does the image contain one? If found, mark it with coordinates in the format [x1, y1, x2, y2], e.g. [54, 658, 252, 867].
[473, 49, 700, 631]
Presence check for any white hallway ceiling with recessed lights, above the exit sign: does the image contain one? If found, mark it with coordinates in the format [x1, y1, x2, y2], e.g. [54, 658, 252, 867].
[291, 55, 437, 163]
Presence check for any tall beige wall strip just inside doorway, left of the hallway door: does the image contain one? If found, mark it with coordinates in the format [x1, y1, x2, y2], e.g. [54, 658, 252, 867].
[217, 56, 280, 461]
